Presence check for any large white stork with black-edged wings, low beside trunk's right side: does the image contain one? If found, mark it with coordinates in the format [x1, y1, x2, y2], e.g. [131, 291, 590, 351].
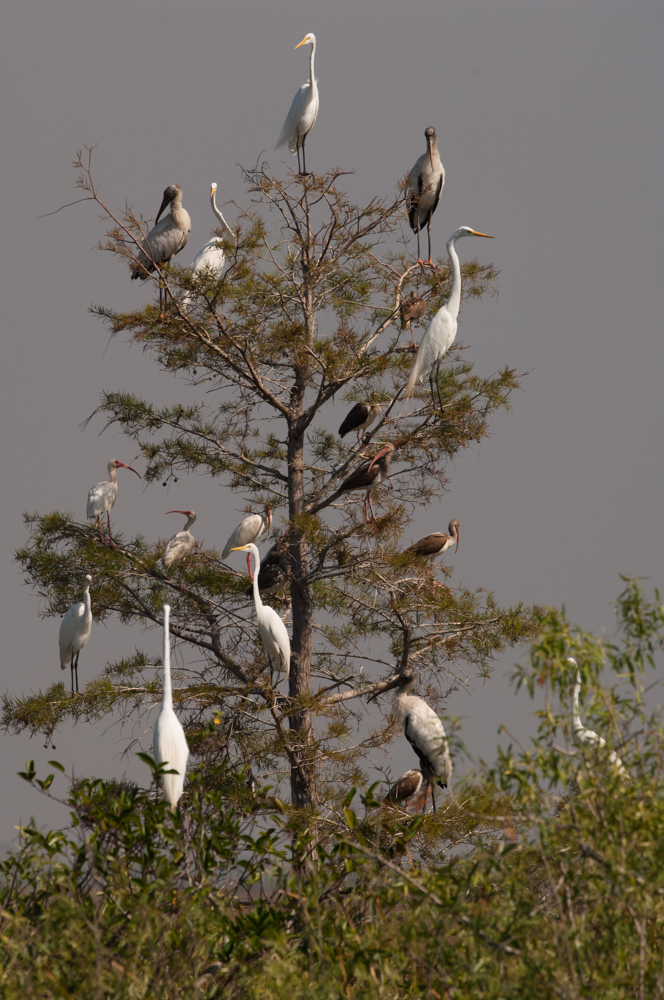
[393, 677, 452, 812]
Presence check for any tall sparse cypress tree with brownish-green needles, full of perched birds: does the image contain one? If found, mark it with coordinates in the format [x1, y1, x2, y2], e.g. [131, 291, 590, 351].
[3, 155, 534, 821]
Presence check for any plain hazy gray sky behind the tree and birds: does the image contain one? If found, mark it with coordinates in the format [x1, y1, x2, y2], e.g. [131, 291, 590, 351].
[0, 0, 664, 844]
